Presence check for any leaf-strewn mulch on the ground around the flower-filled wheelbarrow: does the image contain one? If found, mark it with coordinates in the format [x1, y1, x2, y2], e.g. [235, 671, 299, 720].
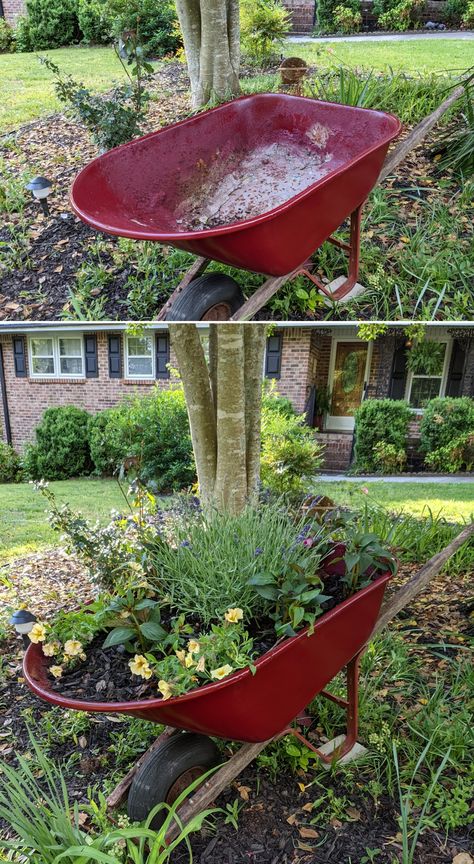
[0, 550, 472, 864]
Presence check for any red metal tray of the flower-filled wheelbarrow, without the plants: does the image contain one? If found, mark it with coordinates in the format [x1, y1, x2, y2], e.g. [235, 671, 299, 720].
[24, 573, 390, 741]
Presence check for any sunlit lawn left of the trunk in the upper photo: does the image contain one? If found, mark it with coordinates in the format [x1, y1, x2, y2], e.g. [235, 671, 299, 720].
[0, 47, 155, 134]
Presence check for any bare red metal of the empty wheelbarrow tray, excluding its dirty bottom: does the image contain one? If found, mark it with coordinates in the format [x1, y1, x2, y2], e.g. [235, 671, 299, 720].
[71, 93, 401, 276]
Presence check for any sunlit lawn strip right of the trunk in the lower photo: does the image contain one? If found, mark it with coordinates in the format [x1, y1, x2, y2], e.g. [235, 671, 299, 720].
[314, 480, 474, 523]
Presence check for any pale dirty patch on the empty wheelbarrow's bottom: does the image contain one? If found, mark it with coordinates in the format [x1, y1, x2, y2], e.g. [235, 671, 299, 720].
[176, 131, 337, 231]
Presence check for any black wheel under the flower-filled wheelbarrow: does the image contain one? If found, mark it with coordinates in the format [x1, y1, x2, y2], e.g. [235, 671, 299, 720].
[127, 732, 220, 828]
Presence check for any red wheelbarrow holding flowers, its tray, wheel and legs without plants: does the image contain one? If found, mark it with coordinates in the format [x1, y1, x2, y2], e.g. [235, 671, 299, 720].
[24, 572, 391, 832]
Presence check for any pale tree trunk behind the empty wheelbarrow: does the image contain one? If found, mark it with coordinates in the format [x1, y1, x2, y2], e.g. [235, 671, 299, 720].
[176, 0, 240, 108]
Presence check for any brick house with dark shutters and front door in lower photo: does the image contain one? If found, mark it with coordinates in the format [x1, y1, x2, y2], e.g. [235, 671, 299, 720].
[0, 322, 474, 471]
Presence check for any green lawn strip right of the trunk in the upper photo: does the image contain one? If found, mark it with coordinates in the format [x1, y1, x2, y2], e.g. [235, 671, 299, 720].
[283, 39, 474, 73]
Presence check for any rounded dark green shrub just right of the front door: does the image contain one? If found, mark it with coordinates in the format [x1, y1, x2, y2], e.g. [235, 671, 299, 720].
[355, 399, 411, 471]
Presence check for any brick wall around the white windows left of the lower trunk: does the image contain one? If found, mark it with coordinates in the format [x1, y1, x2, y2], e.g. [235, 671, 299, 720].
[0, 333, 176, 450]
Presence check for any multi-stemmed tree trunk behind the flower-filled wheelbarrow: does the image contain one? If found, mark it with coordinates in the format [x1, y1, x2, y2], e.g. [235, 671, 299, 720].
[169, 323, 266, 514]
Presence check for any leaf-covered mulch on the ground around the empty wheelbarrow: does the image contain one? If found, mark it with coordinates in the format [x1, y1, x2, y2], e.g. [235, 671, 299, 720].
[0, 62, 470, 321]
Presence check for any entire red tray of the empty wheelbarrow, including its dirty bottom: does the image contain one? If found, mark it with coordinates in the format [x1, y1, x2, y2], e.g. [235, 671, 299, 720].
[71, 93, 401, 276]
